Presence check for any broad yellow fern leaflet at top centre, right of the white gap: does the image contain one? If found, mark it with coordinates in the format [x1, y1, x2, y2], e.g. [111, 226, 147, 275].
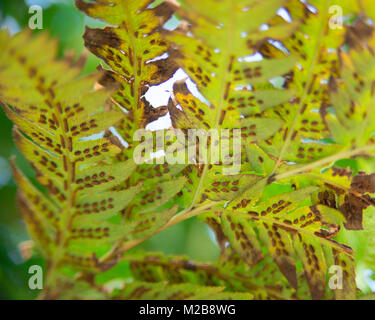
[167, 1, 296, 207]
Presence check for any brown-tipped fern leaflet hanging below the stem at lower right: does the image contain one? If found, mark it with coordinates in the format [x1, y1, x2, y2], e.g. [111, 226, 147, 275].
[221, 187, 352, 299]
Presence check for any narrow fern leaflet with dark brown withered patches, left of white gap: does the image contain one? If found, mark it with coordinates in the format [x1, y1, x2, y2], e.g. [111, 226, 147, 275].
[76, 0, 191, 252]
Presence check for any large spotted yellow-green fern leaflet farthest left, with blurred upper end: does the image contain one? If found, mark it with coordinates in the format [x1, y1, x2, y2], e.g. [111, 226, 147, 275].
[0, 31, 139, 282]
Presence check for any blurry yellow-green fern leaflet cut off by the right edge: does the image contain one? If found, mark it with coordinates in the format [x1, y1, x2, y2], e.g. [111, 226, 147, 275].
[325, 26, 375, 147]
